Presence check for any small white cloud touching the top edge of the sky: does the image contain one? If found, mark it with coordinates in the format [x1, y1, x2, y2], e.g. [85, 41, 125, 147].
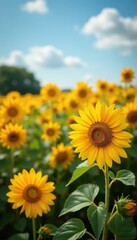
[22, 0, 48, 14]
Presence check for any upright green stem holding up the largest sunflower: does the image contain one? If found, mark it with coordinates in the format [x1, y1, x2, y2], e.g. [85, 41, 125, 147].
[102, 164, 109, 240]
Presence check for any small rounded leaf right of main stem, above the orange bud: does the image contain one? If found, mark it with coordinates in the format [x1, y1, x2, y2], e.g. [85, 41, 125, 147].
[116, 169, 135, 186]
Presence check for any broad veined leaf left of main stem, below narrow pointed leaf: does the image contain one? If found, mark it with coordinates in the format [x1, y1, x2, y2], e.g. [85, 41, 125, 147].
[60, 184, 99, 216]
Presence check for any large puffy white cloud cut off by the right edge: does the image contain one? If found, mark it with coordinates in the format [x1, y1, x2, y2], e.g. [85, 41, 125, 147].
[82, 8, 137, 54]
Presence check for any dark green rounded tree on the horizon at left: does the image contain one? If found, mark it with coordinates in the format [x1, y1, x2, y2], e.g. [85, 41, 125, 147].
[0, 66, 40, 95]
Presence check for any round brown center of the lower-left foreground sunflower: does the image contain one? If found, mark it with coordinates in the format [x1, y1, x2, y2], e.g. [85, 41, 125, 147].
[23, 184, 41, 203]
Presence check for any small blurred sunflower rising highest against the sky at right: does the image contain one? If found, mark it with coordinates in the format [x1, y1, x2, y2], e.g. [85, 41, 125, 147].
[121, 68, 135, 83]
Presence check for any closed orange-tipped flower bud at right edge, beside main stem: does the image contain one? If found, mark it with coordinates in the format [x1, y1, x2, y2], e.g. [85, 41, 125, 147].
[116, 198, 137, 217]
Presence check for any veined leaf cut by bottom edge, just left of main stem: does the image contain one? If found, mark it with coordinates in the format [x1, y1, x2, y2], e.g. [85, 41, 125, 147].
[53, 218, 86, 240]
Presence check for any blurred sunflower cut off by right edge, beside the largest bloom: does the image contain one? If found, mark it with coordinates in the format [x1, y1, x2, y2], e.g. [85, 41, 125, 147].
[123, 99, 137, 128]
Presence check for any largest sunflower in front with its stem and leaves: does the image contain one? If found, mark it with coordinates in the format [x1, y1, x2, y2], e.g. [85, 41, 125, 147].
[54, 101, 135, 240]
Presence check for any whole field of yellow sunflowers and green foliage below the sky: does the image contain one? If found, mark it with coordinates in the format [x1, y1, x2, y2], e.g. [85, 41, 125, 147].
[0, 68, 137, 240]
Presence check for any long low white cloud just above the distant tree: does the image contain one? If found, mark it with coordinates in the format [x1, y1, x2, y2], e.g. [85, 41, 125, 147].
[0, 45, 85, 70]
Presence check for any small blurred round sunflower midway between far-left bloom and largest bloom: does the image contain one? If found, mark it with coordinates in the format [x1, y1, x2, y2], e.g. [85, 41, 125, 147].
[42, 121, 61, 142]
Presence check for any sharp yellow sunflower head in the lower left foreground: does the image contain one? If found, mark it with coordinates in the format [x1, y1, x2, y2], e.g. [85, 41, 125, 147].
[7, 168, 56, 218]
